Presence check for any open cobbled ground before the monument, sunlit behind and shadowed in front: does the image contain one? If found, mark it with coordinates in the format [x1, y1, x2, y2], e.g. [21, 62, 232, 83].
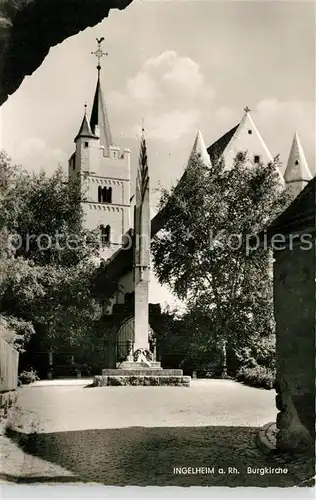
[1, 380, 312, 487]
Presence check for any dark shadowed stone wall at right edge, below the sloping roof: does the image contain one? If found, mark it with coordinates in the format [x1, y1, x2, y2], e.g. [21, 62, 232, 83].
[274, 244, 315, 451]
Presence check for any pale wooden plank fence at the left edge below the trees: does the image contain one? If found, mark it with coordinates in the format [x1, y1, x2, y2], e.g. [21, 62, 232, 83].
[0, 337, 19, 392]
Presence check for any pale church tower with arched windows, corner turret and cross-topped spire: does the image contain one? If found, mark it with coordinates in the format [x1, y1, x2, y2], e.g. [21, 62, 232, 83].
[68, 38, 131, 259]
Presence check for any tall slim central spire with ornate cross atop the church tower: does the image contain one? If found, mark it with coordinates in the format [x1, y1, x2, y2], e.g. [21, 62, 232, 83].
[90, 37, 113, 148]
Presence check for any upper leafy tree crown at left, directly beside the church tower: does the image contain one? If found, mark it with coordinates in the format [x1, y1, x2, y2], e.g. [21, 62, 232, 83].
[0, 161, 100, 267]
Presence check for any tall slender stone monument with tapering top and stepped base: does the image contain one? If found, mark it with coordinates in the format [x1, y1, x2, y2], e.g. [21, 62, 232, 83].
[94, 129, 191, 387]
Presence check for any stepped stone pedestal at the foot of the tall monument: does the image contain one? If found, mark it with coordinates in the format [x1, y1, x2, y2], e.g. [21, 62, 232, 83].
[93, 361, 191, 387]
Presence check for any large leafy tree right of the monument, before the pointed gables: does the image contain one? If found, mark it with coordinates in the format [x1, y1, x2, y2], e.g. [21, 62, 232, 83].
[152, 153, 289, 375]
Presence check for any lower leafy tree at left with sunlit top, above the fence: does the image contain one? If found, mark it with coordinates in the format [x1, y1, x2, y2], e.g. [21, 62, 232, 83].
[0, 257, 115, 362]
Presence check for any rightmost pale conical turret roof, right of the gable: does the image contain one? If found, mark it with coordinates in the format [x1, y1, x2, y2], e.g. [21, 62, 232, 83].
[284, 132, 313, 182]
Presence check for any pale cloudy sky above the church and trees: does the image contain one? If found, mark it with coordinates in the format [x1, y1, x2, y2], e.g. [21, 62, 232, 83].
[0, 0, 315, 304]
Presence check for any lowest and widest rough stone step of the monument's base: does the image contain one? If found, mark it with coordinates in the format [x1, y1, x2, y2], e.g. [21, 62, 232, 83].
[93, 370, 191, 387]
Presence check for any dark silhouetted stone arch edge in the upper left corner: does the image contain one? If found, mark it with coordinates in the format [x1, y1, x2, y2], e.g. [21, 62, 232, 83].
[0, 0, 132, 105]
